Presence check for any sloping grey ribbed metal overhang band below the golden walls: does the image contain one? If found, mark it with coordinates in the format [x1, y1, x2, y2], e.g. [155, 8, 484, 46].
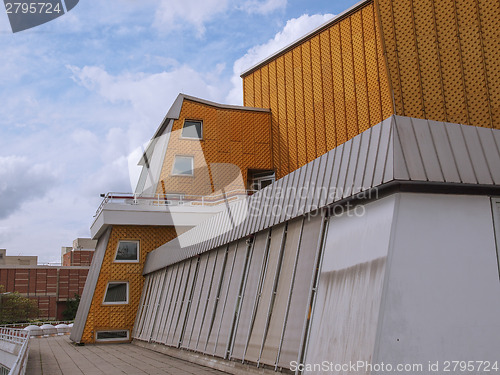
[144, 116, 500, 274]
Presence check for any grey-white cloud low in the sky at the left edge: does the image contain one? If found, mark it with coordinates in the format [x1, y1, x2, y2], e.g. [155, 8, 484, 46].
[0, 156, 56, 219]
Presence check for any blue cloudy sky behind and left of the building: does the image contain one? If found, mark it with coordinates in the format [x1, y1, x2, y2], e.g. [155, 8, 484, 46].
[0, 0, 357, 263]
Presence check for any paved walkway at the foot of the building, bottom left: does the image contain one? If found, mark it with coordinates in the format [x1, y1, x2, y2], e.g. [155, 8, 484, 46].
[26, 336, 227, 375]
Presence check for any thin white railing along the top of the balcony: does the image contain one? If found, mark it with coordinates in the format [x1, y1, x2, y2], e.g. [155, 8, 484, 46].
[94, 189, 255, 217]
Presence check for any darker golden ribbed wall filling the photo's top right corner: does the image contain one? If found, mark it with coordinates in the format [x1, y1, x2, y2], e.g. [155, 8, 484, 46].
[375, 0, 500, 129]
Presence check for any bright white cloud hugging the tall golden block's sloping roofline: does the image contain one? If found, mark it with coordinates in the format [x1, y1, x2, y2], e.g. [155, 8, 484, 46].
[226, 14, 334, 105]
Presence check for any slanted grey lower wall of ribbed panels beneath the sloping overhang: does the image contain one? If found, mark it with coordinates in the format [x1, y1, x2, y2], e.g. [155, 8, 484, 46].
[133, 215, 325, 368]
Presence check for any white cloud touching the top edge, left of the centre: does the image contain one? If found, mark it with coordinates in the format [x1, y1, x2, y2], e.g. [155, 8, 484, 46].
[153, 0, 229, 37]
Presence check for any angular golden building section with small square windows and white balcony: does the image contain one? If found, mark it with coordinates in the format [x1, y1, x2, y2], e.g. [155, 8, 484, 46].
[72, 94, 274, 343]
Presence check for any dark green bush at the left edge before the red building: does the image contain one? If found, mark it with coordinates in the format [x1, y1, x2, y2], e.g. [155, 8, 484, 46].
[0, 285, 39, 324]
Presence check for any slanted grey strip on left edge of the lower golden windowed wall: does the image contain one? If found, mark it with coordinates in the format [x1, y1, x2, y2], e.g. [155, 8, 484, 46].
[70, 227, 111, 343]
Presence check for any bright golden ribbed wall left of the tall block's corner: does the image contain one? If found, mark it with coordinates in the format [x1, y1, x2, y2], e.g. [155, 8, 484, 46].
[243, 2, 394, 177]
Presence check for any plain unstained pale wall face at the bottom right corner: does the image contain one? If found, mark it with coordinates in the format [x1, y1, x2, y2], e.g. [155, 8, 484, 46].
[374, 193, 500, 373]
